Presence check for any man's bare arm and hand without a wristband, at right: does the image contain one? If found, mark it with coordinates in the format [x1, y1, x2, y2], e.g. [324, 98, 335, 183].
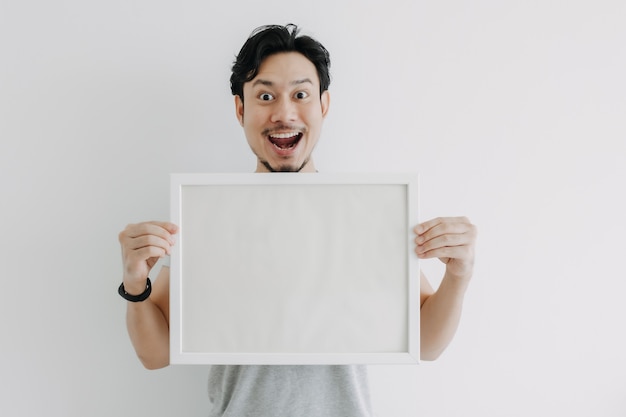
[415, 217, 476, 360]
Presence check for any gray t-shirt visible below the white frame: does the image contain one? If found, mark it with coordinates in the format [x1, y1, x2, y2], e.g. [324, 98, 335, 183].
[209, 365, 372, 417]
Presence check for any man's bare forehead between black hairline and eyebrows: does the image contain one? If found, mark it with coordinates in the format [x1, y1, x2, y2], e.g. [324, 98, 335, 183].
[244, 52, 319, 88]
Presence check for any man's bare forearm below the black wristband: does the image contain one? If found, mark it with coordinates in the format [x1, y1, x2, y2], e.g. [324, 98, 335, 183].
[126, 299, 170, 369]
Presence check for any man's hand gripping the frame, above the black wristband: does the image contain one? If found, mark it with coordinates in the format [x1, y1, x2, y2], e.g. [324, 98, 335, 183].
[119, 222, 178, 294]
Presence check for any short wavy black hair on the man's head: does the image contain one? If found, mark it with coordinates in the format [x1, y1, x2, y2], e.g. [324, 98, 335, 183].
[230, 24, 330, 100]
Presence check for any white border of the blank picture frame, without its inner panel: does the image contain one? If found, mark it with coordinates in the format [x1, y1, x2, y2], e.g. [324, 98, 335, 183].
[170, 173, 420, 365]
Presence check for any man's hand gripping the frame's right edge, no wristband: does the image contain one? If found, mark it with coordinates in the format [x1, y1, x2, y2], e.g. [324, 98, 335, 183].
[414, 217, 477, 279]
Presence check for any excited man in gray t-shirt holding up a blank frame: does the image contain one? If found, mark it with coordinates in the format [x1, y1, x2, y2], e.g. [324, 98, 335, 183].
[119, 25, 476, 417]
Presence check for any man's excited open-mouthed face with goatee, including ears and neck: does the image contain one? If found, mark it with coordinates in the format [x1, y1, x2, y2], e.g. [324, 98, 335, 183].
[235, 52, 329, 172]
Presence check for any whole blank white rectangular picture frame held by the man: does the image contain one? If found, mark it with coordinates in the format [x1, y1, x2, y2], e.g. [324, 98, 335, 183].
[170, 173, 420, 365]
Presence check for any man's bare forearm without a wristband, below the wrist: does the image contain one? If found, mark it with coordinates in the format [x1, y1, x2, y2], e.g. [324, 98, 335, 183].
[420, 274, 469, 360]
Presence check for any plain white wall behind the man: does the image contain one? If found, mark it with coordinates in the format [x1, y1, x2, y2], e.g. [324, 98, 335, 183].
[0, 0, 626, 417]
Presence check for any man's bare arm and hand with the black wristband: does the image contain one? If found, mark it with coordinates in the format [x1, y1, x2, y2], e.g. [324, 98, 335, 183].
[119, 222, 177, 369]
